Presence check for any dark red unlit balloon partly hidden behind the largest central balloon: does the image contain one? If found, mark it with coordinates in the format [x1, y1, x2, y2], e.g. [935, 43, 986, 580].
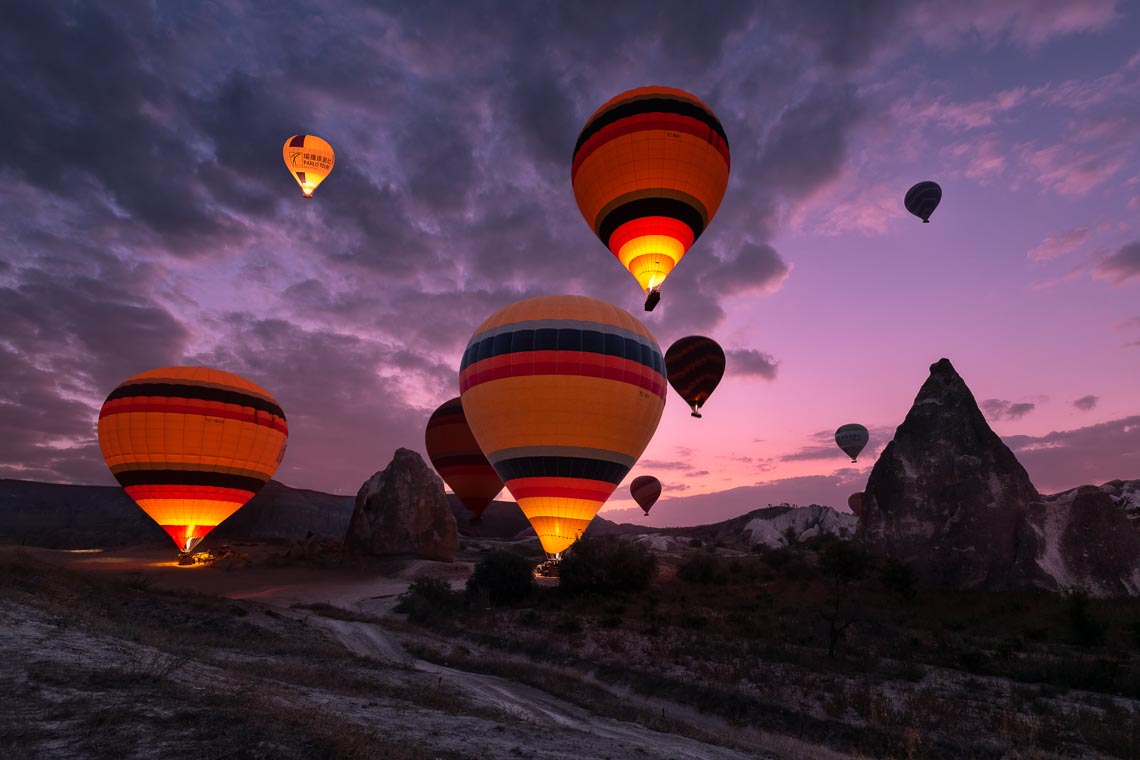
[424, 398, 503, 525]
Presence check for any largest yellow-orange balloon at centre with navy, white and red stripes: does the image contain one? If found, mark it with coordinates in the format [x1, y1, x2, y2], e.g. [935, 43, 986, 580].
[459, 295, 666, 557]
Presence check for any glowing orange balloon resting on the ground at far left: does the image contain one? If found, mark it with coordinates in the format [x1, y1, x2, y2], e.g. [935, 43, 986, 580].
[99, 367, 288, 553]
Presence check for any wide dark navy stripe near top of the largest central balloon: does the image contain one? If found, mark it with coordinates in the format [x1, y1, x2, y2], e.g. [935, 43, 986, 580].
[459, 327, 665, 375]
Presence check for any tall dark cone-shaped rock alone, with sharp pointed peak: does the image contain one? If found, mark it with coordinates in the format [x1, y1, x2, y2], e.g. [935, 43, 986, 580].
[862, 359, 1041, 589]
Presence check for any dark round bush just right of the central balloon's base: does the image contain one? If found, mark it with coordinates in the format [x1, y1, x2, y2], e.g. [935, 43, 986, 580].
[559, 536, 657, 594]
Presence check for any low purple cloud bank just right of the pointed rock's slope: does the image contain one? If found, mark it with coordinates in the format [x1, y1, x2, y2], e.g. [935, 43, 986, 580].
[1002, 416, 1140, 492]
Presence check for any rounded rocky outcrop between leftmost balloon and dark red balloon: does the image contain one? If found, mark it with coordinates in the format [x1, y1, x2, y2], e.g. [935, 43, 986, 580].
[344, 449, 459, 562]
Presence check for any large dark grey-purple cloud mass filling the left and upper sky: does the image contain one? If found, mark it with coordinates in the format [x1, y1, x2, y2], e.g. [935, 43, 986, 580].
[0, 0, 907, 491]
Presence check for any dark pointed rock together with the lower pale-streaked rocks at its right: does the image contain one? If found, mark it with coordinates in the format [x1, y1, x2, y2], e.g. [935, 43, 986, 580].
[861, 359, 1140, 596]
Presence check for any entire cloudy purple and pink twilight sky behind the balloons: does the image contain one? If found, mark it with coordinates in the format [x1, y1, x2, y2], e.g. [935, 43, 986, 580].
[0, 0, 1140, 525]
